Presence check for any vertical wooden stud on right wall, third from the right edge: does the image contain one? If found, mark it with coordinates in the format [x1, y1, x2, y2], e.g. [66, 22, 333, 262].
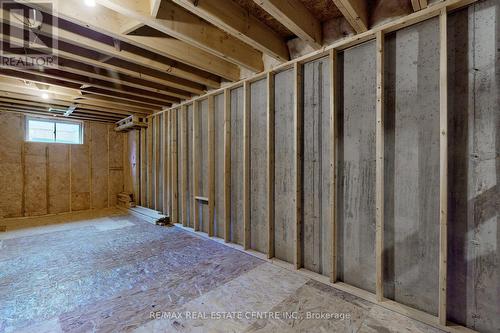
[329, 49, 339, 283]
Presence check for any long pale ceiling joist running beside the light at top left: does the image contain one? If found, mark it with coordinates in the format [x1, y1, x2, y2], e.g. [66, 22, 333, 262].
[30, 0, 239, 82]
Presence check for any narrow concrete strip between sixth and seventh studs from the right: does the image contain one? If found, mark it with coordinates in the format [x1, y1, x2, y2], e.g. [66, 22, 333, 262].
[231, 87, 243, 245]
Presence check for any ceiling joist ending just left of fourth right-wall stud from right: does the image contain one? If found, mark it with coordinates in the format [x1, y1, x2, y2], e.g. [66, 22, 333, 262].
[173, 0, 290, 62]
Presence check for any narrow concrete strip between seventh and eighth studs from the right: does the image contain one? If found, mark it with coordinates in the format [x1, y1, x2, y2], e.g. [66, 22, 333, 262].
[214, 94, 226, 238]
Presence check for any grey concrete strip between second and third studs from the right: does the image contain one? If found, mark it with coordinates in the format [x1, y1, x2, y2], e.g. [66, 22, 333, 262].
[337, 42, 376, 292]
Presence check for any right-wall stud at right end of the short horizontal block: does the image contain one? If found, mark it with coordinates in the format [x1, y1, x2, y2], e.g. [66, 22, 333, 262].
[207, 95, 215, 237]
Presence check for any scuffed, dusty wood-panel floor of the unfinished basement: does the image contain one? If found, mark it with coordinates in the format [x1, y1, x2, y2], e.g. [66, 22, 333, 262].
[0, 210, 446, 333]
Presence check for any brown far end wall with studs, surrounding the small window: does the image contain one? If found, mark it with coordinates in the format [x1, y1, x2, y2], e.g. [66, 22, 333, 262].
[0, 112, 128, 218]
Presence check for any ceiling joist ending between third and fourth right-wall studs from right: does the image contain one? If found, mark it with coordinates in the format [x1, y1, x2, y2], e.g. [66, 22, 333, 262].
[254, 0, 323, 50]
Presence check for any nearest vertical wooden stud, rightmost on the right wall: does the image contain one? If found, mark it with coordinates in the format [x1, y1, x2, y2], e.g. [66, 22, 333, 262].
[438, 8, 448, 325]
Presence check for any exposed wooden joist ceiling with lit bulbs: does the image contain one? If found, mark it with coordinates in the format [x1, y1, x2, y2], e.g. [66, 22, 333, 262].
[0, 0, 418, 122]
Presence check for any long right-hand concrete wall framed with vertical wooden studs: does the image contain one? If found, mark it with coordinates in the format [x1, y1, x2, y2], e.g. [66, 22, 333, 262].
[136, 0, 500, 333]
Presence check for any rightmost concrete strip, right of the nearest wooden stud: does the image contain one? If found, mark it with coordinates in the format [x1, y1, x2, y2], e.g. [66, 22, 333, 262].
[448, 0, 500, 333]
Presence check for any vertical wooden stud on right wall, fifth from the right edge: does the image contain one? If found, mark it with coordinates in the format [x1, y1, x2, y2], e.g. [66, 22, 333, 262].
[267, 73, 275, 259]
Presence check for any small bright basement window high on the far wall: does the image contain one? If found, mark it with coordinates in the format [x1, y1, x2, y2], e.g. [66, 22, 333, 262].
[26, 118, 83, 144]
